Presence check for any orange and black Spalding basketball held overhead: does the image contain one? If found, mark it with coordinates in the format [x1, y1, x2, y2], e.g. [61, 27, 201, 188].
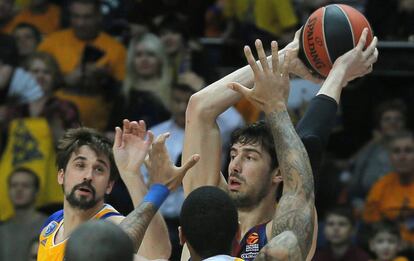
[299, 4, 373, 78]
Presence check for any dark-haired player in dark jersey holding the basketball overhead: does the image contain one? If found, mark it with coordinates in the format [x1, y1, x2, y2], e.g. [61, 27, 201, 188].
[182, 29, 378, 260]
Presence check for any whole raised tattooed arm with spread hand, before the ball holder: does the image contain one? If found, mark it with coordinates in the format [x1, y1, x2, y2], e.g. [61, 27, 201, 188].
[230, 40, 315, 260]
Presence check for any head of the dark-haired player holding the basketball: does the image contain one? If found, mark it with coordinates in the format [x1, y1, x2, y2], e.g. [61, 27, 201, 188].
[228, 121, 282, 209]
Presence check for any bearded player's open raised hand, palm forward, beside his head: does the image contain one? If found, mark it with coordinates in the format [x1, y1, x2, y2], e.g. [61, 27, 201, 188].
[113, 119, 154, 178]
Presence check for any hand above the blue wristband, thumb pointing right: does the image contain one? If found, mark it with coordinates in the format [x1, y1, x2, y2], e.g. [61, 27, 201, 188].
[145, 133, 200, 191]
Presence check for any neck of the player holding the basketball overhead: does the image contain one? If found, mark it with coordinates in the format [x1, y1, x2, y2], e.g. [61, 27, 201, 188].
[237, 193, 276, 237]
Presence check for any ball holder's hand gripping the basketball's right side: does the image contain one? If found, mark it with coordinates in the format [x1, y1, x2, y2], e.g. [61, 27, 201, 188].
[332, 28, 378, 86]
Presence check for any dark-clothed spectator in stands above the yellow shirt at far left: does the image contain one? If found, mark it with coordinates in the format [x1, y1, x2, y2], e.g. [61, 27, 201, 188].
[24, 52, 80, 142]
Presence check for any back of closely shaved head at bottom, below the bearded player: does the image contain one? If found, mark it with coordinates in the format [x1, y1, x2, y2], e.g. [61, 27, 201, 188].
[65, 220, 134, 261]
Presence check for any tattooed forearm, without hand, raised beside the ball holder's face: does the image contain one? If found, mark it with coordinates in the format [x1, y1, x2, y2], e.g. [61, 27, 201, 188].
[266, 105, 314, 195]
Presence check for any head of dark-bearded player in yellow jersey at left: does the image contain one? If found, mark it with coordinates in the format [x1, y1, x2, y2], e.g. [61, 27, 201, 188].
[57, 127, 119, 210]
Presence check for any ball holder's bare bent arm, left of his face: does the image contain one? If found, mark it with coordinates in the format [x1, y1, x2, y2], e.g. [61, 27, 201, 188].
[183, 29, 320, 195]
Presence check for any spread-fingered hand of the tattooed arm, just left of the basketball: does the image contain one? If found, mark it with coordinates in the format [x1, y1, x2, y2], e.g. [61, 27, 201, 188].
[228, 40, 292, 113]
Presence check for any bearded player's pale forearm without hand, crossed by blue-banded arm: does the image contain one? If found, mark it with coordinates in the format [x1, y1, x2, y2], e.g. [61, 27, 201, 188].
[122, 171, 171, 259]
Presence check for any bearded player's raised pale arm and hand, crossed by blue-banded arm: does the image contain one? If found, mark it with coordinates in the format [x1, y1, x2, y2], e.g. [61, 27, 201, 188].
[113, 120, 171, 259]
